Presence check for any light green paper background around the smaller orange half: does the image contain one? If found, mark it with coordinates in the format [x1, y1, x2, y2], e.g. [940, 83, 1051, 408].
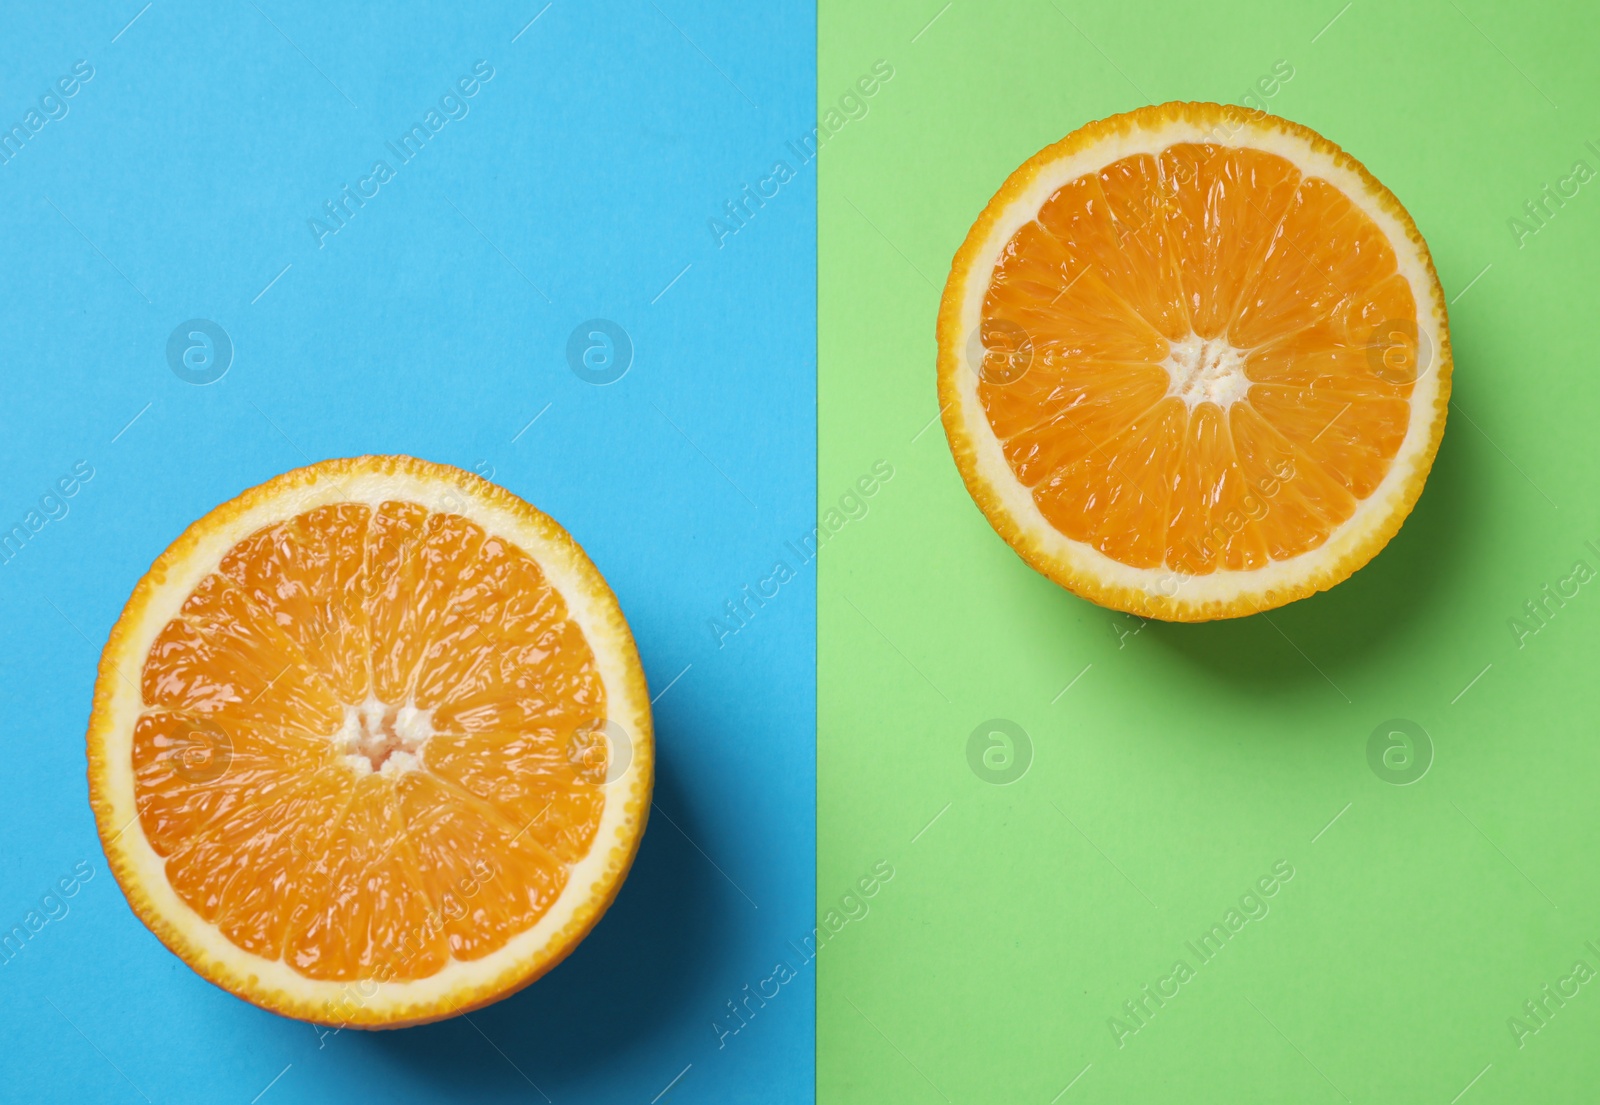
[818, 0, 1600, 1105]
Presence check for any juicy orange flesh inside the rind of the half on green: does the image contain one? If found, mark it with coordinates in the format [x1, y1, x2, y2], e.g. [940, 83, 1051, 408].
[978, 144, 1418, 576]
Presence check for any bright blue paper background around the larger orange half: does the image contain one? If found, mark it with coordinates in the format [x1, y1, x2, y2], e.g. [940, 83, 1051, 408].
[0, 0, 816, 1105]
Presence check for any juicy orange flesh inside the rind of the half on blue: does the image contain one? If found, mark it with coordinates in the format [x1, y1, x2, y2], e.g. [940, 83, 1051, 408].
[133, 502, 606, 980]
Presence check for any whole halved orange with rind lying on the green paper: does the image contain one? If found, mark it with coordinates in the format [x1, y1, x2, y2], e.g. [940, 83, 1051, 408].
[938, 104, 1451, 620]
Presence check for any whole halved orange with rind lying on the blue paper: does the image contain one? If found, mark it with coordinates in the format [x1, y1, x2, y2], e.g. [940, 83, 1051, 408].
[88, 457, 654, 1027]
